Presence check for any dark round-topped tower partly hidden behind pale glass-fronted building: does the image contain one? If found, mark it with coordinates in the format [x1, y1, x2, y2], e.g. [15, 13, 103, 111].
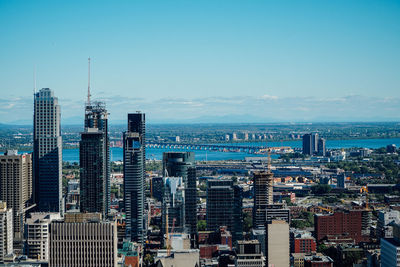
[163, 152, 197, 238]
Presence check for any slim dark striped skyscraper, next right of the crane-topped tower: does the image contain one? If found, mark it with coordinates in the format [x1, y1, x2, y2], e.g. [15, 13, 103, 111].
[123, 112, 146, 243]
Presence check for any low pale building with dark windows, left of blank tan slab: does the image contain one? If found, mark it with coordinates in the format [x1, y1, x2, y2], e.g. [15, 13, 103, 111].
[235, 240, 264, 267]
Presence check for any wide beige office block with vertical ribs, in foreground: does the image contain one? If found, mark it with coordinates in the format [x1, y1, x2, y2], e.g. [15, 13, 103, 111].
[49, 213, 117, 267]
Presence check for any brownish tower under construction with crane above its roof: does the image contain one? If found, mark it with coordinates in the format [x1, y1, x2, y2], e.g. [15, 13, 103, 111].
[253, 171, 274, 228]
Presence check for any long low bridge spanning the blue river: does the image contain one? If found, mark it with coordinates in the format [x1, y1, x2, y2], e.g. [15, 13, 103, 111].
[146, 142, 294, 154]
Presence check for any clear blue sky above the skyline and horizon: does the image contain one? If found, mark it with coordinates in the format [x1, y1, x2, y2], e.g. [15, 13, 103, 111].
[0, 0, 400, 123]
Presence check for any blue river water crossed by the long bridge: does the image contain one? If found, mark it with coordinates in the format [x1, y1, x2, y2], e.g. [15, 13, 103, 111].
[57, 138, 400, 162]
